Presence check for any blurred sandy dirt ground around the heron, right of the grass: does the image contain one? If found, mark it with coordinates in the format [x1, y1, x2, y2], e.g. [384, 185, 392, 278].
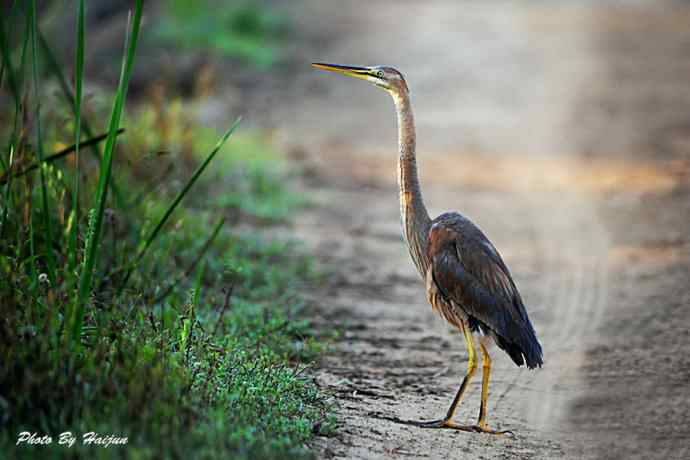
[222, 0, 690, 459]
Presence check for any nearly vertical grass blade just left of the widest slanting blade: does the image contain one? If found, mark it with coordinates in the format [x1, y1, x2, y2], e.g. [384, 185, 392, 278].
[69, 0, 84, 273]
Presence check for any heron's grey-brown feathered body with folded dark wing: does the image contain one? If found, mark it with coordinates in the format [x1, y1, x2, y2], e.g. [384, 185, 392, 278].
[426, 213, 542, 369]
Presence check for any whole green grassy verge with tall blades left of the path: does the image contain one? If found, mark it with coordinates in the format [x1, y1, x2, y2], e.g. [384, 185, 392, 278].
[0, 1, 334, 459]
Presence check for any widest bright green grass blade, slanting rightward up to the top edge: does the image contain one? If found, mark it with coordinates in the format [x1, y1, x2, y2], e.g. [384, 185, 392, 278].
[71, 0, 143, 344]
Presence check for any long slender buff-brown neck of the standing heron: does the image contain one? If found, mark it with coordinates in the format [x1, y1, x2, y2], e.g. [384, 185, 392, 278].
[393, 92, 431, 278]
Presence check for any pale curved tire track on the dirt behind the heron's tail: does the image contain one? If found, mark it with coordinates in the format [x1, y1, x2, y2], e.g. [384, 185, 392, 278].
[520, 192, 609, 434]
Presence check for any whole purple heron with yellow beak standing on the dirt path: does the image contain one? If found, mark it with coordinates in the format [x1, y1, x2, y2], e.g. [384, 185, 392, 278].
[312, 62, 543, 435]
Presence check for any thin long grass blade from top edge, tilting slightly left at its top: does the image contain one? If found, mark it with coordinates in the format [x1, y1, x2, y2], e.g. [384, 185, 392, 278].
[29, 0, 56, 286]
